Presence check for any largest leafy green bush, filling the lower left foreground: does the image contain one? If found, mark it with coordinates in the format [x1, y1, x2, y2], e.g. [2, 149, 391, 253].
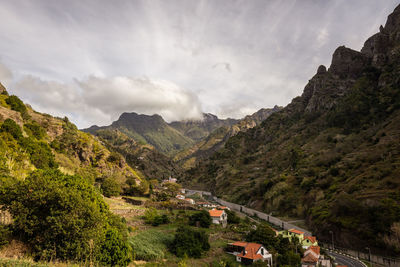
[0, 170, 130, 262]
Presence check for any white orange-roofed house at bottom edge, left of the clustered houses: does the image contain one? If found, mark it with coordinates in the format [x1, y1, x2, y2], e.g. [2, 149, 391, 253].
[226, 241, 272, 266]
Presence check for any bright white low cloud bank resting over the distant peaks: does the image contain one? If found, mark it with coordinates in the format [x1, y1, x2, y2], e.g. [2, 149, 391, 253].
[13, 75, 202, 128]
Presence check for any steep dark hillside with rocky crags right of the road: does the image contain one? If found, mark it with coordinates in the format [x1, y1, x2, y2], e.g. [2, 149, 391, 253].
[185, 7, 400, 253]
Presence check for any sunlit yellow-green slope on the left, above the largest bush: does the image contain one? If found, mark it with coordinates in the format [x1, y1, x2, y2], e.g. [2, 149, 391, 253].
[0, 87, 147, 193]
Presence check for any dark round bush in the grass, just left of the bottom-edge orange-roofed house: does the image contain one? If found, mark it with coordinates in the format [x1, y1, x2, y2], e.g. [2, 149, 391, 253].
[170, 226, 210, 258]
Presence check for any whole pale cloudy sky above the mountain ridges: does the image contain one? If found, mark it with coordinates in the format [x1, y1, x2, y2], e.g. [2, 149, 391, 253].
[0, 0, 398, 128]
